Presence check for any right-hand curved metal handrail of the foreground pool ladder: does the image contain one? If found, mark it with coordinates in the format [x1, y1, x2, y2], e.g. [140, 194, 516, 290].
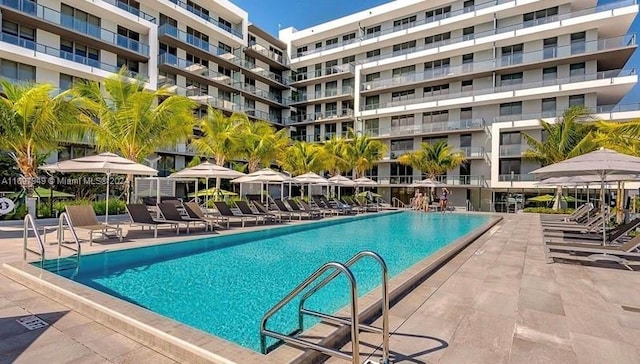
[298, 250, 389, 364]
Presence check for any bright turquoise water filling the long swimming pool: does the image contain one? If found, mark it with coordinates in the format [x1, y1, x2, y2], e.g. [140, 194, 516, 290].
[38, 212, 489, 351]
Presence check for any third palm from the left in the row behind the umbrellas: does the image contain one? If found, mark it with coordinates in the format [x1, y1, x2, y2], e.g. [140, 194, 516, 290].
[191, 107, 246, 166]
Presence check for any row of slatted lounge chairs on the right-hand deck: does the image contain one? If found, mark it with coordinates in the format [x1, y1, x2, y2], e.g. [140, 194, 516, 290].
[541, 204, 640, 270]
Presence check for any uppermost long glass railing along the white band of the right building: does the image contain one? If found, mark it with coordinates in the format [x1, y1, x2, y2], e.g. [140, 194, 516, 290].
[362, 0, 637, 63]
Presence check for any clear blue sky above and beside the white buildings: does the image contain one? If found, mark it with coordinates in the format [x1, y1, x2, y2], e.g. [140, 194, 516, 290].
[231, 0, 640, 104]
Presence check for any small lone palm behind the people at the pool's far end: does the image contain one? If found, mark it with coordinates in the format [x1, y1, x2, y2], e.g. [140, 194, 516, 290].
[398, 140, 466, 179]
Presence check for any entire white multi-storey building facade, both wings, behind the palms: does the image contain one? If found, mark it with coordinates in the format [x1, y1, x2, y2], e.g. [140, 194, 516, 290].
[0, 0, 640, 210]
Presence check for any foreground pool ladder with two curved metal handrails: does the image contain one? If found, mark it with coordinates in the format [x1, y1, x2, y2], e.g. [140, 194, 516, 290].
[260, 251, 390, 364]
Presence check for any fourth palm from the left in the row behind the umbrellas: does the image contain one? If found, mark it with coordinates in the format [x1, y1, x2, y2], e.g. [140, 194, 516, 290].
[238, 115, 290, 173]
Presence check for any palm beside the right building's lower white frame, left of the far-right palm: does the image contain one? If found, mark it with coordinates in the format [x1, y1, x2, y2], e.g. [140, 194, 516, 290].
[522, 106, 598, 167]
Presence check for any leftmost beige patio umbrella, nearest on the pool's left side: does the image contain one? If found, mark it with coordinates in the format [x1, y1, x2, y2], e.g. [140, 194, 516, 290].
[40, 153, 158, 223]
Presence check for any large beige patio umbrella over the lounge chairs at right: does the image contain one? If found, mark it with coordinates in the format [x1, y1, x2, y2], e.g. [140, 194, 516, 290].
[531, 148, 640, 245]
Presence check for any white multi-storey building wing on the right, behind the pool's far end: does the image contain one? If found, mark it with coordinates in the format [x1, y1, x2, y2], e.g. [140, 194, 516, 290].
[279, 0, 640, 210]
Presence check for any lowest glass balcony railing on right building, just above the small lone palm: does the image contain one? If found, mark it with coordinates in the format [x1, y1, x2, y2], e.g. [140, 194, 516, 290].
[367, 118, 485, 137]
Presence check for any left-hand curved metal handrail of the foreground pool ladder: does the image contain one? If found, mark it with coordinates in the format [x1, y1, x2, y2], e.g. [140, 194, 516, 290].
[260, 262, 360, 364]
